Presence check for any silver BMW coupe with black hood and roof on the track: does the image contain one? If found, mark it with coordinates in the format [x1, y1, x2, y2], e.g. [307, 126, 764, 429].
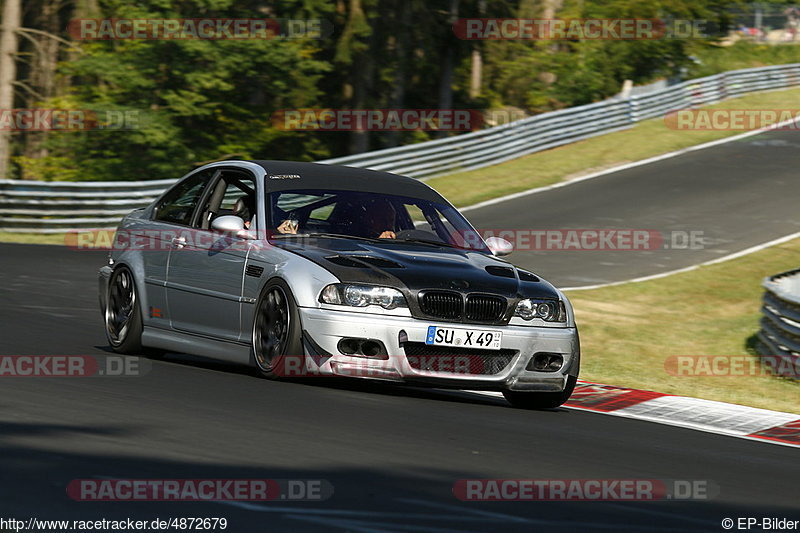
[100, 161, 580, 408]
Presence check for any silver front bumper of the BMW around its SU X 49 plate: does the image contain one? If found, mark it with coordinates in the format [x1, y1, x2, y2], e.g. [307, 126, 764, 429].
[299, 307, 580, 392]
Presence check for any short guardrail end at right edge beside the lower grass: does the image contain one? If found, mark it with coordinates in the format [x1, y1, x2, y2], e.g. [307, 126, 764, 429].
[757, 268, 800, 379]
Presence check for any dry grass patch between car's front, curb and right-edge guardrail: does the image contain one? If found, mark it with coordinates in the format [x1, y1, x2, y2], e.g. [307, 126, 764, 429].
[569, 239, 800, 414]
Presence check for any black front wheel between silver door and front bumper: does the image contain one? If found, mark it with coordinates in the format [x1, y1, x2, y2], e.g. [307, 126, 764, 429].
[253, 279, 305, 380]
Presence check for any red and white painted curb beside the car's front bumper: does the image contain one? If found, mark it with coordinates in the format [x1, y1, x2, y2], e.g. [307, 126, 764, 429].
[472, 381, 800, 448]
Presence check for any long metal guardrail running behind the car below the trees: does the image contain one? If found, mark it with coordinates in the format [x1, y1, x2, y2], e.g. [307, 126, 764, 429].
[0, 63, 800, 233]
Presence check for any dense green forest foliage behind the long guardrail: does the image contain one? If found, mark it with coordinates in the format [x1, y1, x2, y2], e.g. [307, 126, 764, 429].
[13, 0, 797, 180]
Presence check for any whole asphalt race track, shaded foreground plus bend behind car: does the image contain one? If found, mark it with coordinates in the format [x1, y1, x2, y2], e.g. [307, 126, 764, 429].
[0, 133, 800, 532]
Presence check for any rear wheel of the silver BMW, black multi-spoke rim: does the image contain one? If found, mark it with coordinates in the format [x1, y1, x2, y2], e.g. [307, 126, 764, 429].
[104, 267, 142, 354]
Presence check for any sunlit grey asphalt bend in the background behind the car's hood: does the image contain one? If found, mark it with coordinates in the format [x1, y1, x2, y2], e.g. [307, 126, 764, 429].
[465, 131, 800, 287]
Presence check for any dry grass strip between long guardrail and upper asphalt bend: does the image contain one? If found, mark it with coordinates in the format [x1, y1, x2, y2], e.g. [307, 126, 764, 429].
[427, 89, 800, 207]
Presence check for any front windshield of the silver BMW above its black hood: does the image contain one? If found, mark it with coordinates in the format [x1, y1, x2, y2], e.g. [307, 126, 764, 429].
[267, 189, 488, 252]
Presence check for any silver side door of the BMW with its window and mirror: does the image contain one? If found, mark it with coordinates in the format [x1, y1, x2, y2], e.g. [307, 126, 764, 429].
[167, 168, 256, 341]
